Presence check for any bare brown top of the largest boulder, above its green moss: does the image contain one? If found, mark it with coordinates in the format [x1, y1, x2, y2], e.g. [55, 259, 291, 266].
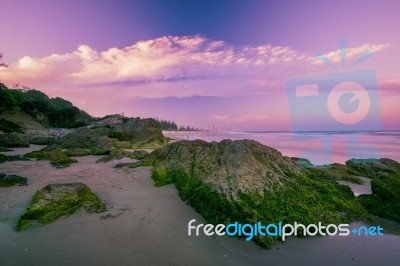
[146, 140, 301, 198]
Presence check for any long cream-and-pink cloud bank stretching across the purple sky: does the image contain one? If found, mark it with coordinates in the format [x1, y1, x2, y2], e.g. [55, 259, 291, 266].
[0, 35, 388, 98]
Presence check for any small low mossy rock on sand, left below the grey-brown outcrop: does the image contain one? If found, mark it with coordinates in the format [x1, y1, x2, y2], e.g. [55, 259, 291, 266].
[24, 148, 78, 168]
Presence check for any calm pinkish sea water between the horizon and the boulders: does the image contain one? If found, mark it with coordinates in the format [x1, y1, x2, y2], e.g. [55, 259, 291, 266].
[163, 131, 400, 165]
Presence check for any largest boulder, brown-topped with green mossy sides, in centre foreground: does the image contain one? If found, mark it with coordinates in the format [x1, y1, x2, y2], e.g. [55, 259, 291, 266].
[145, 140, 367, 247]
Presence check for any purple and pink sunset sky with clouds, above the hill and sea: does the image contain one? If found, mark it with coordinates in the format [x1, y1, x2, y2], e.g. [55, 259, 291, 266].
[0, 0, 400, 131]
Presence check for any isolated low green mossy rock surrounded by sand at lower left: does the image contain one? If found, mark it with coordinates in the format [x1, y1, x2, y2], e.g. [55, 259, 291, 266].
[14, 183, 106, 231]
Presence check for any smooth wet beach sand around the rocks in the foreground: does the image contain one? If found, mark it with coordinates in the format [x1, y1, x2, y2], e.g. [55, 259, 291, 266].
[0, 146, 400, 265]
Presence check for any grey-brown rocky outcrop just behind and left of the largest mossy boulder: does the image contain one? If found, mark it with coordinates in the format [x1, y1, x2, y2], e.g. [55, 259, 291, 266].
[48, 115, 165, 154]
